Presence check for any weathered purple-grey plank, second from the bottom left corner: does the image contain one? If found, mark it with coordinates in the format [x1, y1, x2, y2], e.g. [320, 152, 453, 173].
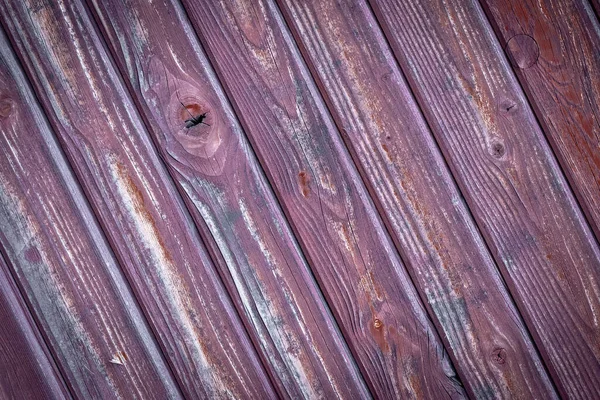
[0, 26, 179, 399]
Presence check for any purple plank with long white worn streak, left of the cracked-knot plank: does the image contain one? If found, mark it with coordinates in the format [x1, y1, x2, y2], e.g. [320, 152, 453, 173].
[0, 1, 274, 398]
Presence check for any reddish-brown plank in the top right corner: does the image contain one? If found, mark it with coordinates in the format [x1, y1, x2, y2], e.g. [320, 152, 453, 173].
[482, 0, 600, 238]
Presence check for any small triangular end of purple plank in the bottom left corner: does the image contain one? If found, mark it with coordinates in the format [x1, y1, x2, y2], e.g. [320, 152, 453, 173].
[0, 252, 71, 400]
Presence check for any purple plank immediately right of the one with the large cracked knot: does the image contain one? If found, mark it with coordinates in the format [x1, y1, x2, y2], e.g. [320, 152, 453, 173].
[177, 1, 474, 398]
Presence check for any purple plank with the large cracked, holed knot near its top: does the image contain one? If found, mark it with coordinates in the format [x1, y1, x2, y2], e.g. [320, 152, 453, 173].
[84, 1, 369, 398]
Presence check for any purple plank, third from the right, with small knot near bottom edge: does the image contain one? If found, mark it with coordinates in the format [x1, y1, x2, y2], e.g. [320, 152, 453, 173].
[279, 0, 556, 398]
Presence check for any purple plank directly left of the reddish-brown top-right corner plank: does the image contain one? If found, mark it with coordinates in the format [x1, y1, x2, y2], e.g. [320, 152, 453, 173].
[371, 0, 600, 398]
